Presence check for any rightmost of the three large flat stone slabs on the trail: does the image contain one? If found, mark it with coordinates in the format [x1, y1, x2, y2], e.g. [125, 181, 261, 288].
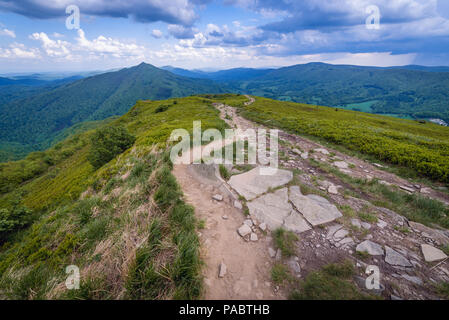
[290, 186, 342, 226]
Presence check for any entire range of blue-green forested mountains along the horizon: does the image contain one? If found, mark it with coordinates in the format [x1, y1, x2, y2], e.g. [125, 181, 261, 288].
[0, 63, 449, 161]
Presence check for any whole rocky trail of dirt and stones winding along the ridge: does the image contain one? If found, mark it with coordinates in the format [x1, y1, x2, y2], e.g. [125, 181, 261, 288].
[174, 96, 449, 299]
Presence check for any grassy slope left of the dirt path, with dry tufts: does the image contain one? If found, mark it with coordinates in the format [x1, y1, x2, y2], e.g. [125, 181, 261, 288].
[0, 97, 225, 299]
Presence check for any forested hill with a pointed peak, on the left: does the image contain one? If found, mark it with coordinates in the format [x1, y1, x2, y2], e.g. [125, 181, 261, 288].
[0, 63, 221, 160]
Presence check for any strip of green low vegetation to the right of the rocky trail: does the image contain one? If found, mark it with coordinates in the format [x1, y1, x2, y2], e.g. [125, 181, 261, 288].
[236, 98, 449, 183]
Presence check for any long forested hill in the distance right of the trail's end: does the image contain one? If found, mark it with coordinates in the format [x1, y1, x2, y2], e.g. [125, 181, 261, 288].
[219, 63, 449, 122]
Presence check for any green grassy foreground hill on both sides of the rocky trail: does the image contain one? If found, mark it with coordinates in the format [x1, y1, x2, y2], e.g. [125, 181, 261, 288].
[0, 94, 449, 299]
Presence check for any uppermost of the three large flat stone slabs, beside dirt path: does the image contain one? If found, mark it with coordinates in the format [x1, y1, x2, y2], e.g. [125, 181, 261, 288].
[229, 167, 293, 201]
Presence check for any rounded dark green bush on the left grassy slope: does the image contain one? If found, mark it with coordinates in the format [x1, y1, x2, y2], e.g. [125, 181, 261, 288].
[88, 126, 136, 169]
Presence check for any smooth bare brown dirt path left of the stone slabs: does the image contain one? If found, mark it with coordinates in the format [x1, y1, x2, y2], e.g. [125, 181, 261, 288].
[173, 165, 282, 300]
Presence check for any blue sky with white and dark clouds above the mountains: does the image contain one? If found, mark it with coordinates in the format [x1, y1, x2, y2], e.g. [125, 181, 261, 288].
[0, 0, 449, 74]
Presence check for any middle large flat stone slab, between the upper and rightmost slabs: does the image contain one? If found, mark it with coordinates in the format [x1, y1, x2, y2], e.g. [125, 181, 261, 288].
[247, 188, 311, 233]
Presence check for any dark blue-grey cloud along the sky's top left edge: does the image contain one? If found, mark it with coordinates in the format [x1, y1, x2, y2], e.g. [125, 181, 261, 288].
[0, 0, 209, 26]
